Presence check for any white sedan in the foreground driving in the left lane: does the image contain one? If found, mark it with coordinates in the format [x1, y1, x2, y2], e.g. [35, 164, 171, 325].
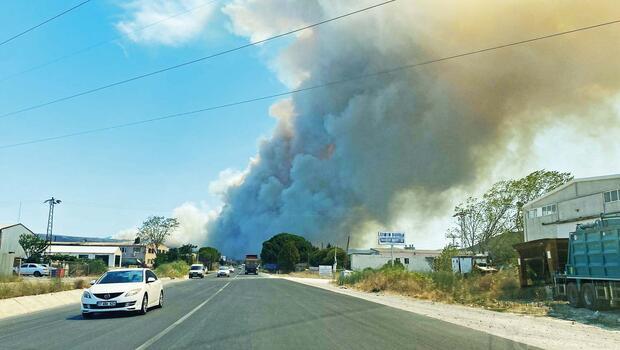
[82, 269, 164, 318]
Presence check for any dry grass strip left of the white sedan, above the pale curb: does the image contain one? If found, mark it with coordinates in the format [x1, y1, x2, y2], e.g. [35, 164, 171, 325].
[0, 278, 89, 299]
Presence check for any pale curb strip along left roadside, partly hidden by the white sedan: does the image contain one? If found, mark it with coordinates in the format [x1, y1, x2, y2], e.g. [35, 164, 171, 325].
[0, 277, 187, 319]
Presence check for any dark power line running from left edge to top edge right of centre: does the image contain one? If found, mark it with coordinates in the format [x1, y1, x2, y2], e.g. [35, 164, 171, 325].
[0, 0, 396, 118]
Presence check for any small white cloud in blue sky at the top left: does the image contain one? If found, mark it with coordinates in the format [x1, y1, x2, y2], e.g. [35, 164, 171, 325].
[116, 0, 217, 46]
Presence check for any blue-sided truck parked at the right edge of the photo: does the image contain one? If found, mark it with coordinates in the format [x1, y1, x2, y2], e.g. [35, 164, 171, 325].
[554, 213, 620, 310]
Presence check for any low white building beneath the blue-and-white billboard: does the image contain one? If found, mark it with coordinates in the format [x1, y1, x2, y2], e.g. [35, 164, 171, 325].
[348, 248, 441, 272]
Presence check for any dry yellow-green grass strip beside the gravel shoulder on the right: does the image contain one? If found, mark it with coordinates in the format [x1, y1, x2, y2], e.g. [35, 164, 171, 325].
[338, 267, 549, 315]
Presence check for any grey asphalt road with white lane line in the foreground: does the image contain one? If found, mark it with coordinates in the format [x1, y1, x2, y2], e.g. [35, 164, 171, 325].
[0, 274, 531, 350]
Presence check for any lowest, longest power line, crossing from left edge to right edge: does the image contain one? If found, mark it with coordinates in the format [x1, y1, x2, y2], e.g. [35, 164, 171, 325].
[0, 20, 620, 149]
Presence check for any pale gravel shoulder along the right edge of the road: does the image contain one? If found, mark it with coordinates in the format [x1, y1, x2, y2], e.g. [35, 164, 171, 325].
[280, 275, 620, 349]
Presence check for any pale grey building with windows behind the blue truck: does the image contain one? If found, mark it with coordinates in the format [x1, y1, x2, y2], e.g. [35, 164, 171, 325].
[523, 174, 620, 242]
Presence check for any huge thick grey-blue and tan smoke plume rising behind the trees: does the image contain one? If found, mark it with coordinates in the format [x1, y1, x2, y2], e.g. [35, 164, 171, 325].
[208, 0, 620, 255]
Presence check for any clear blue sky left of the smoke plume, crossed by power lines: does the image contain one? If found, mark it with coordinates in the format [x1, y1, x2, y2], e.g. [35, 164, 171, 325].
[0, 0, 285, 236]
